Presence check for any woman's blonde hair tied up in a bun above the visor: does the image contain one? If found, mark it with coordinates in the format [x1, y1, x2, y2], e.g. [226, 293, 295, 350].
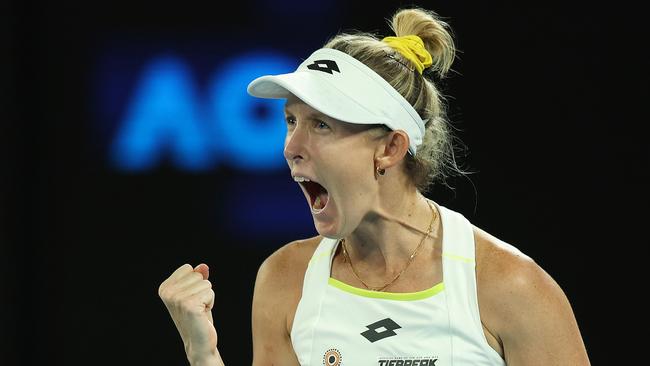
[324, 8, 464, 192]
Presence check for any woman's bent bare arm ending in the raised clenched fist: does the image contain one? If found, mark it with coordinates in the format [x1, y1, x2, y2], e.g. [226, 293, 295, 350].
[158, 242, 309, 366]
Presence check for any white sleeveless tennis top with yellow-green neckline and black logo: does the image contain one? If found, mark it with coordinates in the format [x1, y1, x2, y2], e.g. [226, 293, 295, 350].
[291, 205, 505, 366]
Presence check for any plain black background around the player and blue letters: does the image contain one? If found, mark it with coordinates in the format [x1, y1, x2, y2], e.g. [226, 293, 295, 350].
[0, 0, 649, 365]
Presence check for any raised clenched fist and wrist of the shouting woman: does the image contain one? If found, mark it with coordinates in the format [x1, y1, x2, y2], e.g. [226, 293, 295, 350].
[158, 264, 221, 365]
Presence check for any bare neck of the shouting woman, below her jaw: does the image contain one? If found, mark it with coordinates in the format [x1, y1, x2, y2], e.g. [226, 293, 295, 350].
[345, 189, 437, 276]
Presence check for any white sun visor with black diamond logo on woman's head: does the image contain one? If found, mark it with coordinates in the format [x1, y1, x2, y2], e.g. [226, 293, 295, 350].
[248, 48, 424, 156]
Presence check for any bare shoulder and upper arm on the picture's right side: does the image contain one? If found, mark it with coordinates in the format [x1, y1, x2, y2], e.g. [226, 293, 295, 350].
[474, 227, 589, 365]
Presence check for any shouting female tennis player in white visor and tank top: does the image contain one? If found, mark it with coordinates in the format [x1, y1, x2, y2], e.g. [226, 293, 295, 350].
[159, 8, 589, 366]
